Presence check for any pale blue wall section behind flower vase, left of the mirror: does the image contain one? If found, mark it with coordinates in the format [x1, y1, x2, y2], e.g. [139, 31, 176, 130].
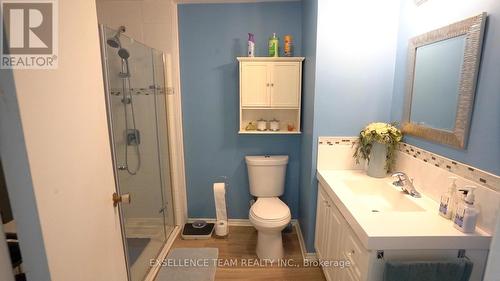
[314, 0, 399, 136]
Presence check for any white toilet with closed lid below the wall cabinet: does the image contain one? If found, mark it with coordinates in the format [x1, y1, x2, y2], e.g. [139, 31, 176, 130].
[245, 155, 291, 260]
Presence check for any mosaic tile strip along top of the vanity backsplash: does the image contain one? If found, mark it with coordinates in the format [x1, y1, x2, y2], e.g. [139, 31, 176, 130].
[319, 137, 500, 192]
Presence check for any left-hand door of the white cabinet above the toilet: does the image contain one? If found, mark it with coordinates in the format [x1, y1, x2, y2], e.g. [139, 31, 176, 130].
[240, 62, 270, 107]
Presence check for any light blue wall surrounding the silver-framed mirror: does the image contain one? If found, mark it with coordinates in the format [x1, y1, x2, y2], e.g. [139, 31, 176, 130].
[391, 0, 500, 175]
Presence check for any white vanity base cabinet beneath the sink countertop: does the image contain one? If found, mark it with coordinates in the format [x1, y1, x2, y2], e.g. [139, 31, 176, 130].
[314, 183, 488, 281]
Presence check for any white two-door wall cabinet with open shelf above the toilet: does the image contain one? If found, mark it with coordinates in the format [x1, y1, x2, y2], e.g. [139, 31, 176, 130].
[238, 57, 304, 134]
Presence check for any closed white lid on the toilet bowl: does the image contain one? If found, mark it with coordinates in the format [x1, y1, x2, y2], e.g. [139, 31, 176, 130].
[250, 197, 290, 220]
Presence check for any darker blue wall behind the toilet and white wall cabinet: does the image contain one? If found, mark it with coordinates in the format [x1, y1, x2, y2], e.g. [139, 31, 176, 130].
[178, 2, 302, 218]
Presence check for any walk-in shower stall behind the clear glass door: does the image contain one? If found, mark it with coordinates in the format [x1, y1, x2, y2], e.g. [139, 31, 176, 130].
[99, 25, 175, 281]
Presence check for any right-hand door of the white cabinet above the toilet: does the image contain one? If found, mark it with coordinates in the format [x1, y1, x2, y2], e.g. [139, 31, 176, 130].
[271, 62, 301, 108]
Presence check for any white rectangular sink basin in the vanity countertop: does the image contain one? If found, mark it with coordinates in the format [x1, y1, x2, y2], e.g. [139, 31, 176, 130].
[344, 179, 425, 213]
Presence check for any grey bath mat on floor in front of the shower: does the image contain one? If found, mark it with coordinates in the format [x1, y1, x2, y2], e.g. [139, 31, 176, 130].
[156, 248, 219, 281]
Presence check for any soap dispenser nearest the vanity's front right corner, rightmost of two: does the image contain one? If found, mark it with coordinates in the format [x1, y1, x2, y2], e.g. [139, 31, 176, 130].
[453, 186, 479, 233]
